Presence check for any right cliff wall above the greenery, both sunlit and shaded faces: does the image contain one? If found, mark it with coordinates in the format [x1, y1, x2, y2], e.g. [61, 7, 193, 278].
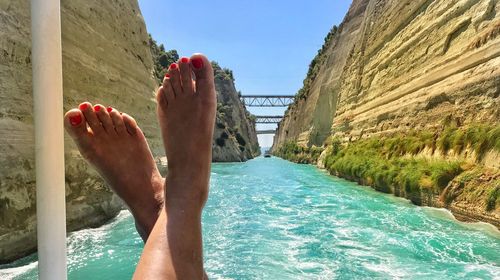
[275, 0, 500, 147]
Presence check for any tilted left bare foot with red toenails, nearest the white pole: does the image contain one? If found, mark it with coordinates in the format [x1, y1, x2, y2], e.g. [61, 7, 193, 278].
[64, 102, 164, 240]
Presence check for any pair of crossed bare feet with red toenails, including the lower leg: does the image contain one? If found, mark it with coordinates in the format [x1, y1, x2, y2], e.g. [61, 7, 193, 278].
[65, 54, 216, 279]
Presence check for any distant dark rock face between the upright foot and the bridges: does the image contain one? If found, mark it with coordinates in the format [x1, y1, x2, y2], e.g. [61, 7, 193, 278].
[212, 64, 260, 162]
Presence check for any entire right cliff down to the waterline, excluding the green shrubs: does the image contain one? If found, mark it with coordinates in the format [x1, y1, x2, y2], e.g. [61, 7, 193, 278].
[273, 0, 500, 225]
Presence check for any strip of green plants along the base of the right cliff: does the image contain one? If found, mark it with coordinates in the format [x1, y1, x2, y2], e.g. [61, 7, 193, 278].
[325, 125, 500, 208]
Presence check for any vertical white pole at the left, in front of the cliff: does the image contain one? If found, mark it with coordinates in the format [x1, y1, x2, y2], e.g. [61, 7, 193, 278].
[31, 0, 67, 280]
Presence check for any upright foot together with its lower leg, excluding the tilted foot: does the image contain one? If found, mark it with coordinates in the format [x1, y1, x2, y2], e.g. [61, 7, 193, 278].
[134, 54, 216, 279]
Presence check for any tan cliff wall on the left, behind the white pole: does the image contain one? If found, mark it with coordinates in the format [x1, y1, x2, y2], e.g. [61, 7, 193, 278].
[0, 0, 162, 262]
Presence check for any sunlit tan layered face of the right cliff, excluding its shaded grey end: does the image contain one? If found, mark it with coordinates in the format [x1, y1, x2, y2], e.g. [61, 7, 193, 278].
[332, 0, 500, 140]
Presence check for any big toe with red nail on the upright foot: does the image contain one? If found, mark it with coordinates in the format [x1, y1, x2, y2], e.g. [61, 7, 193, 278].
[190, 54, 215, 100]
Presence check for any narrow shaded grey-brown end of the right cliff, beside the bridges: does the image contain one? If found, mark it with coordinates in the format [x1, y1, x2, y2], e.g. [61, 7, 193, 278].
[273, 0, 369, 149]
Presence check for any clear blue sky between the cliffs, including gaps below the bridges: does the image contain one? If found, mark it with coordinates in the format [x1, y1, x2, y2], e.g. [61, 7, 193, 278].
[139, 0, 351, 147]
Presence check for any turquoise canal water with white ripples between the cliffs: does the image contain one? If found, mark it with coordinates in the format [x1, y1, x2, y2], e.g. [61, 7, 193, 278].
[0, 158, 500, 279]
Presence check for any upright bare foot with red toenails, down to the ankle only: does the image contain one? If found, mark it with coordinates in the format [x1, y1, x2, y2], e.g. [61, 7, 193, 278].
[157, 55, 217, 206]
